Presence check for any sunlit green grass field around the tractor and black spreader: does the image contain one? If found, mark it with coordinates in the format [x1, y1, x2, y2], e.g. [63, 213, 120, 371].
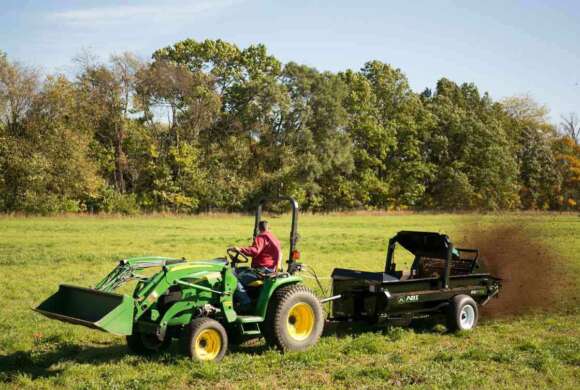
[0, 214, 580, 389]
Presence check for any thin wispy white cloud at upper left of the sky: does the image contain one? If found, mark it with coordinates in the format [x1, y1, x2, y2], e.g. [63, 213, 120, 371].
[49, 0, 241, 24]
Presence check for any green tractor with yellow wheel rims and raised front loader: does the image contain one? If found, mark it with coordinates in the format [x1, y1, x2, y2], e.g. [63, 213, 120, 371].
[35, 198, 324, 361]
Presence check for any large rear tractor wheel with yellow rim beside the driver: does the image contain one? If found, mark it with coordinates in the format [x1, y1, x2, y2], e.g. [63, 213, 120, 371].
[262, 284, 324, 352]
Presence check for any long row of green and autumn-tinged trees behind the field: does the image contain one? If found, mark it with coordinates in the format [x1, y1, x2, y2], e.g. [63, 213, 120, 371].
[0, 39, 580, 213]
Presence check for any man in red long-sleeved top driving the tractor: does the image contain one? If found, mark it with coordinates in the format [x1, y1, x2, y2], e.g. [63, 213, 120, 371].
[233, 221, 282, 311]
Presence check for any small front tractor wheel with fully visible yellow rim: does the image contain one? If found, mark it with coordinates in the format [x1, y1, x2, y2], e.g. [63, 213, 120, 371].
[181, 317, 228, 362]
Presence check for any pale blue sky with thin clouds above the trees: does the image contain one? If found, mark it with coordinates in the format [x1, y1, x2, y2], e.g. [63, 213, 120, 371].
[0, 0, 580, 122]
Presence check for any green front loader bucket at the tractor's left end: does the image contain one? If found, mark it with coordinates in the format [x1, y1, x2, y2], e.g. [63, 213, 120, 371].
[34, 284, 135, 336]
